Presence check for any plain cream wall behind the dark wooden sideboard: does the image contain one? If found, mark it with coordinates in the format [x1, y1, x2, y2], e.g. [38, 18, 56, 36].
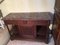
[0, 0, 55, 16]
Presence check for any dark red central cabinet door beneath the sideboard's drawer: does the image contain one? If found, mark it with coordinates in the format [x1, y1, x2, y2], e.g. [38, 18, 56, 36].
[19, 26, 36, 38]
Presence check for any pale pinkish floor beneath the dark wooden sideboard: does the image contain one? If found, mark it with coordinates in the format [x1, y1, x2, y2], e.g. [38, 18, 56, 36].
[7, 38, 54, 45]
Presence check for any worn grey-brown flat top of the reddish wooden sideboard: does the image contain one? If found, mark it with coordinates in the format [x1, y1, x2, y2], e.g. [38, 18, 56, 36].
[3, 12, 52, 20]
